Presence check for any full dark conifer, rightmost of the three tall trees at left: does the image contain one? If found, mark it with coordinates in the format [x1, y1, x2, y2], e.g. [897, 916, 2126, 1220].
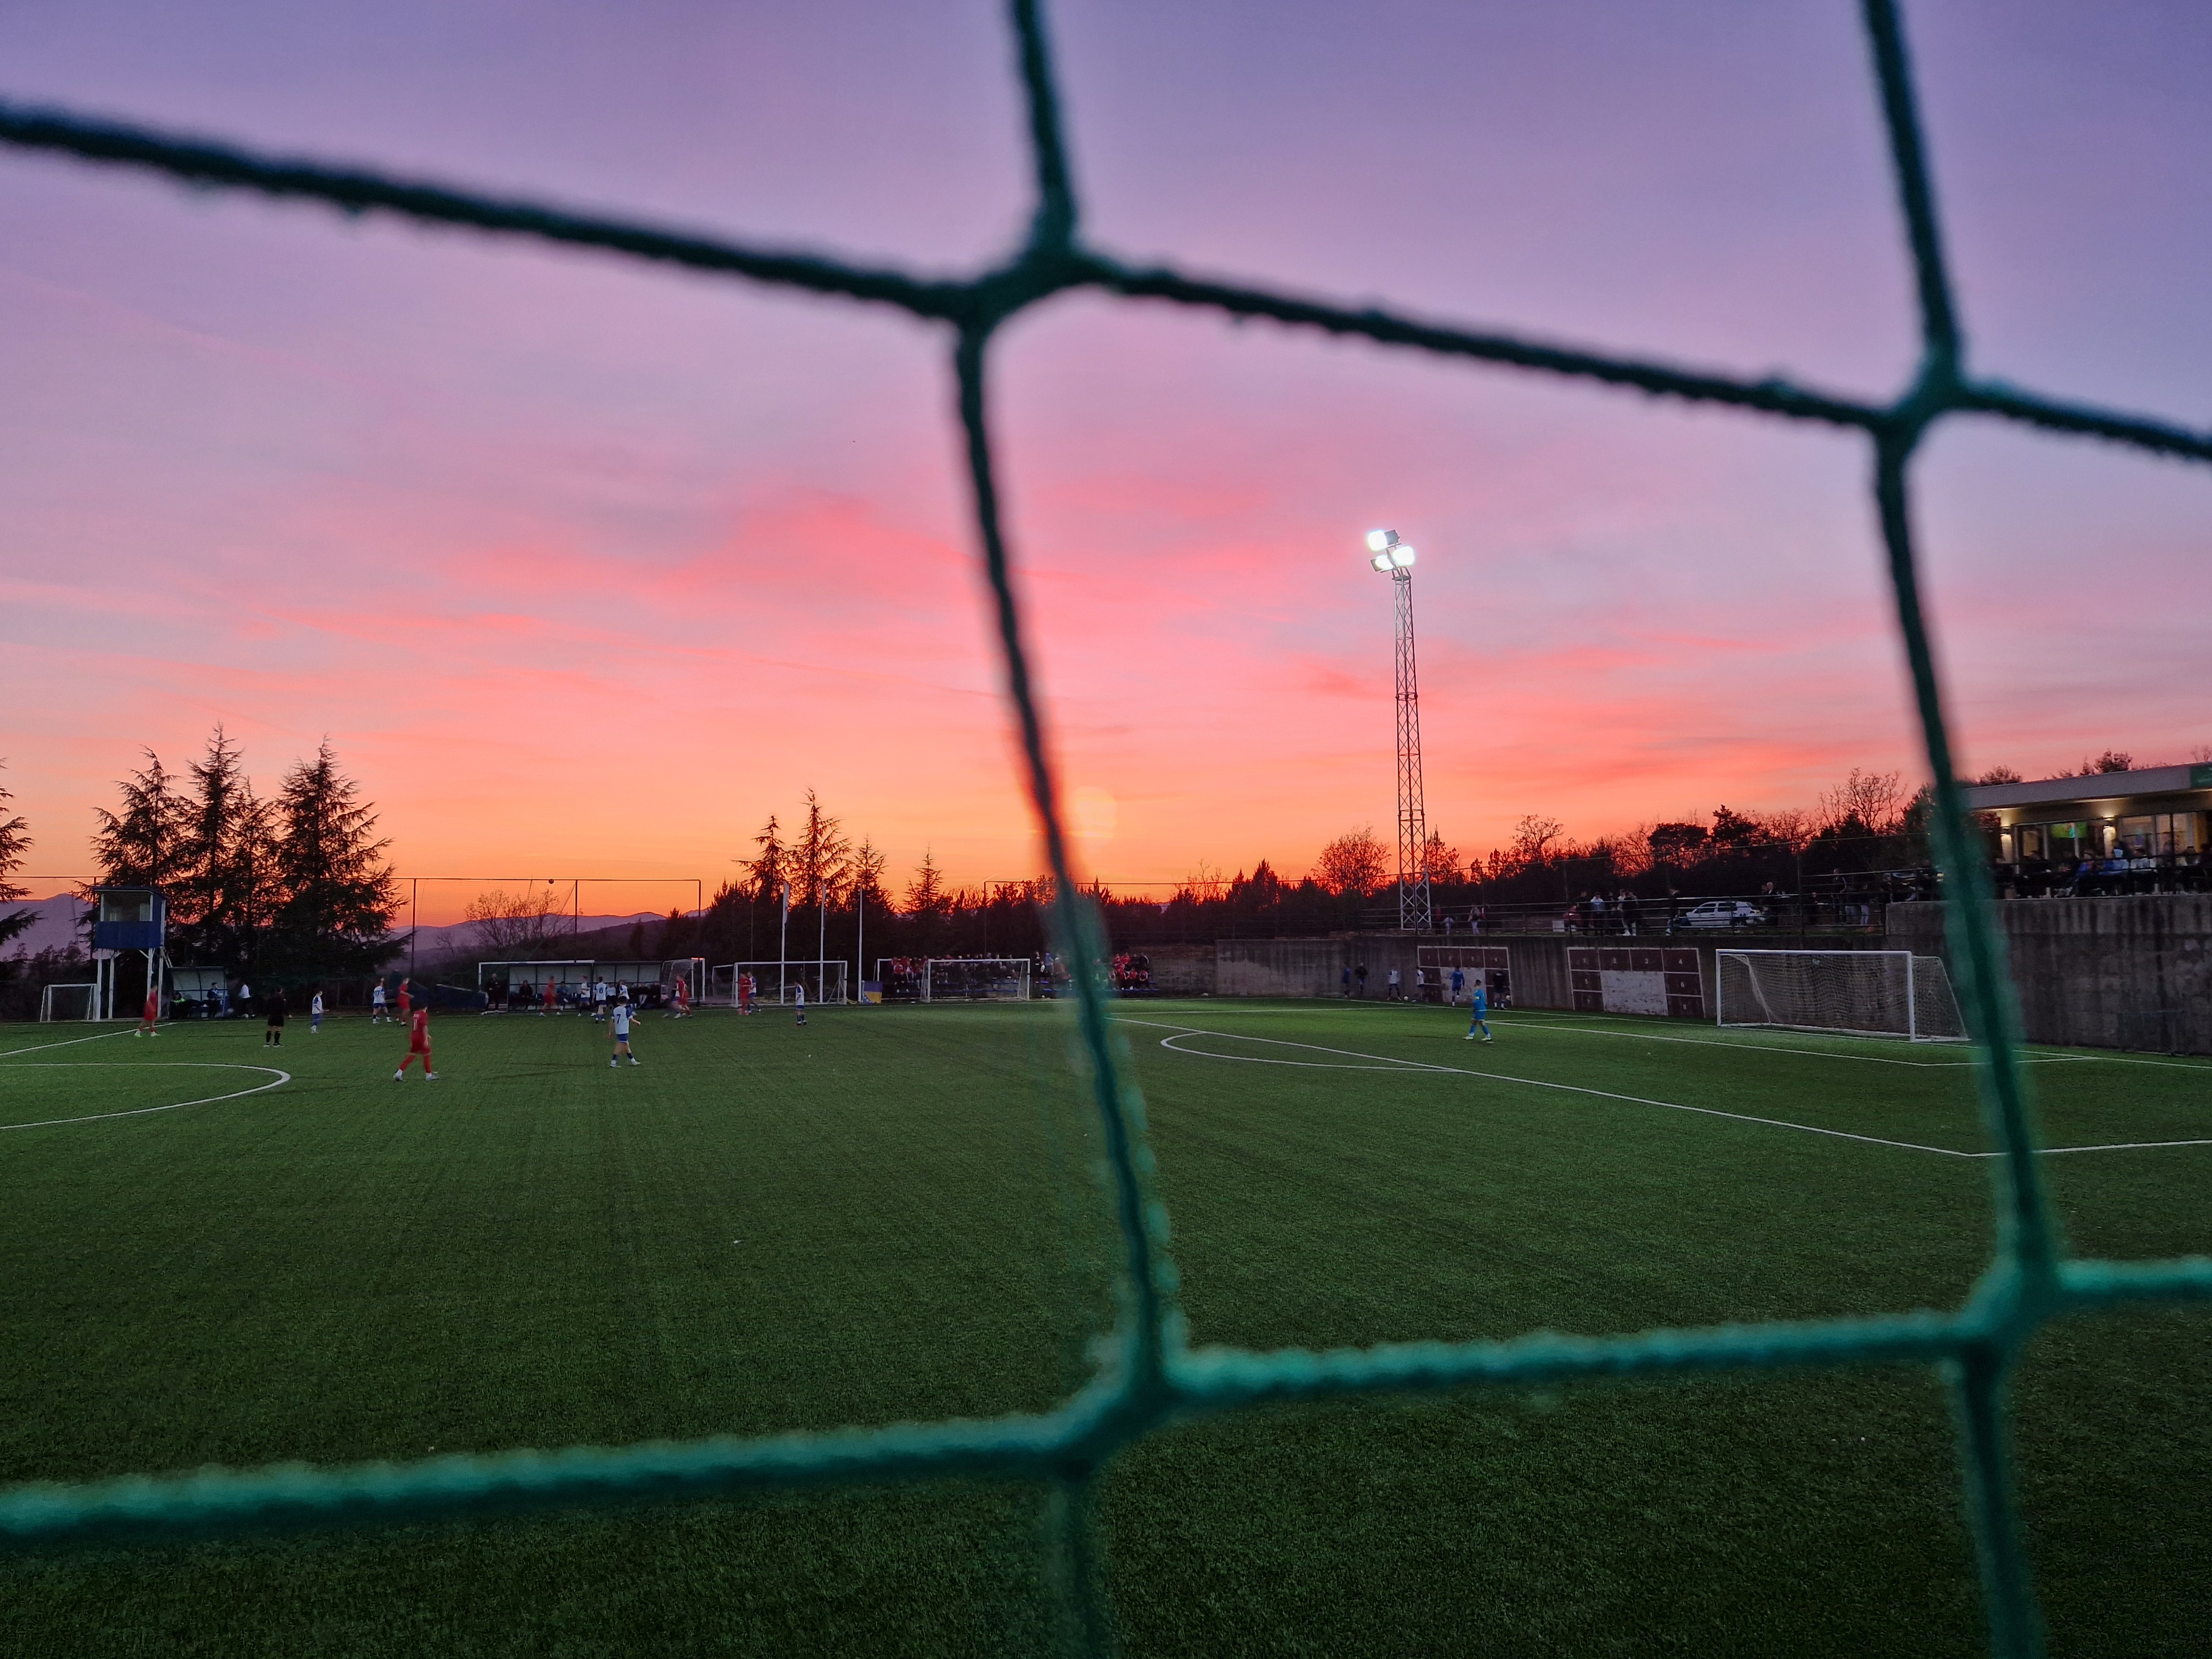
[265, 739, 398, 973]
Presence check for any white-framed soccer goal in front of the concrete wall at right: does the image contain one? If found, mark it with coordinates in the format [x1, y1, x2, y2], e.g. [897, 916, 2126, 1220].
[1714, 951, 1966, 1042]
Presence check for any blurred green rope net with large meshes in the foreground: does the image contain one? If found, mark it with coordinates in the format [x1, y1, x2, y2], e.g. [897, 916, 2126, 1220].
[0, 0, 2212, 1657]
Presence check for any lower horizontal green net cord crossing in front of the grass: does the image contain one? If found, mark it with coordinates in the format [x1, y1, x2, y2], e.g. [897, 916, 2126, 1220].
[0, 1256, 2212, 1548]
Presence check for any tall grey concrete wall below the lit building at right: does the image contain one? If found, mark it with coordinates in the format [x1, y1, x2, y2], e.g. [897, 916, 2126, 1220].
[1885, 894, 2212, 1055]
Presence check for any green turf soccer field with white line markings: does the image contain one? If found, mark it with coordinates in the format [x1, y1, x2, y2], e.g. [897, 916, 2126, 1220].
[0, 1002, 2212, 1655]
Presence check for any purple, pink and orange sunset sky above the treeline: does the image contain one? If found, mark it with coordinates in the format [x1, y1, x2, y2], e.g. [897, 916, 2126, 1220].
[0, 0, 2212, 920]
